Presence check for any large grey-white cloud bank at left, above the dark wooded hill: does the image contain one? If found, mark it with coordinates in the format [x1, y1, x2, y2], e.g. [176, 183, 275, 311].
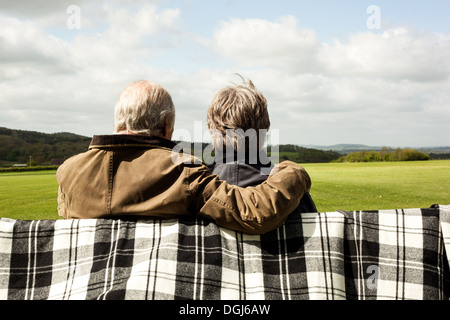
[0, 5, 185, 134]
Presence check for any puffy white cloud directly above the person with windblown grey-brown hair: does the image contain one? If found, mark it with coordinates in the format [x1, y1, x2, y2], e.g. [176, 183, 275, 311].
[214, 16, 319, 72]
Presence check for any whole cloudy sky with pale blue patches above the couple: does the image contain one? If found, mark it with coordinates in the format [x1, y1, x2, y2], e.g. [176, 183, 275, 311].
[0, 0, 450, 147]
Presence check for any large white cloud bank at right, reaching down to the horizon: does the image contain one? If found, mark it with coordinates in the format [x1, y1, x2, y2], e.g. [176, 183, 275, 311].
[210, 19, 450, 145]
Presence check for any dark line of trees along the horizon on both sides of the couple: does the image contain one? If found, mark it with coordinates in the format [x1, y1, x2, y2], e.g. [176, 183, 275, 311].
[0, 127, 438, 166]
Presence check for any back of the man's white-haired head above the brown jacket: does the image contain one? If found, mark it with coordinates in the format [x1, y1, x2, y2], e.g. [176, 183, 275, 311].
[114, 80, 175, 136]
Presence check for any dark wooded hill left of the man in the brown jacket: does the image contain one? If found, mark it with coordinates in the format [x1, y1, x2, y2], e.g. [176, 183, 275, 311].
[0, 127, 91, 166]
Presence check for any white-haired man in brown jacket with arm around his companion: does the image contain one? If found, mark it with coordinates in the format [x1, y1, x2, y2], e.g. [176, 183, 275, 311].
[56, 81, 310, 234]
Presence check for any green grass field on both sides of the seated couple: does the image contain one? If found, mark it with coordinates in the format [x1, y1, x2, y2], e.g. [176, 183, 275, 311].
[0, 160, 450, 220]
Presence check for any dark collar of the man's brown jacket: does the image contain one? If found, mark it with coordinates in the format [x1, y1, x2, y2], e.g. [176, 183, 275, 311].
[89, 134, 176, 149]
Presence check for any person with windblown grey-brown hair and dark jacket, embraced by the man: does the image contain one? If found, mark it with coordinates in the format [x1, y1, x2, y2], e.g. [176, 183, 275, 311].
[207, 77, 317, 212]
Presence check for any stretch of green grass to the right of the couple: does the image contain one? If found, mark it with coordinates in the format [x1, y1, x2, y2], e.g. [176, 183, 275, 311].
[302, 160, 450, 212]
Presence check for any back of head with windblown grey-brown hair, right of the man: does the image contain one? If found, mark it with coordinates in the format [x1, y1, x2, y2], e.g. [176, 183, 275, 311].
[207, 81, 270, 150]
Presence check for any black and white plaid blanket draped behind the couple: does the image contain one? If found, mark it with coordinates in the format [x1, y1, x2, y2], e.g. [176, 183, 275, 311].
[0, 206, 450, 300]
